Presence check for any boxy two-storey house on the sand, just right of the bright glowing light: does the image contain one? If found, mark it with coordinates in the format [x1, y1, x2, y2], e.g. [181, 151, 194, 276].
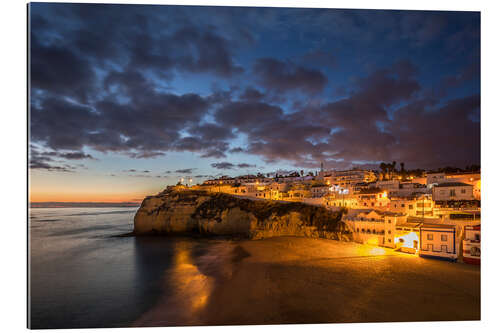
[419, 223, 457, 260]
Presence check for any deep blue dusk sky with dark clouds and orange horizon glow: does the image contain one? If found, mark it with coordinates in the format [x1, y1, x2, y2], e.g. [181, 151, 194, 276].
[29, 3, 480, 202]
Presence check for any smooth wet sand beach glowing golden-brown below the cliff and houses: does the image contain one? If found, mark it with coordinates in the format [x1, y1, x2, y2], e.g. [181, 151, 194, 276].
[134, 237, 480, 326]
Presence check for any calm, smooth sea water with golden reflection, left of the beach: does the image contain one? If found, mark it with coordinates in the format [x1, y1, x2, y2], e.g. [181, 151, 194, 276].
[29, 207, 228, 328]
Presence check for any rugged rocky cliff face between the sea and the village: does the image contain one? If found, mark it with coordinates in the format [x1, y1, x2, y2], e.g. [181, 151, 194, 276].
[134, 189, 352, 240]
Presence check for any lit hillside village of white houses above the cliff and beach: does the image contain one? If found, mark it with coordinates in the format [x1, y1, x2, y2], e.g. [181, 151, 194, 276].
[183, 162, 481, 264]
